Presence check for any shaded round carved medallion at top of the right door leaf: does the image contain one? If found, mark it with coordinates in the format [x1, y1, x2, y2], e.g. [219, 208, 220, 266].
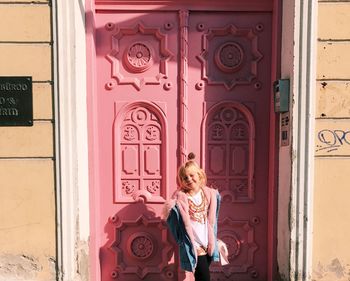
[215, 42, 244, 72]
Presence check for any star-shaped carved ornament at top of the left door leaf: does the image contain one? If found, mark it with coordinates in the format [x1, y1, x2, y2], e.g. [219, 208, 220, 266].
[105, 23, 173, 91]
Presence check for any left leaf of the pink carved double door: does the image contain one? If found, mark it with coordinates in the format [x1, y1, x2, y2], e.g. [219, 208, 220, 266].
[96, 12, 179, 281]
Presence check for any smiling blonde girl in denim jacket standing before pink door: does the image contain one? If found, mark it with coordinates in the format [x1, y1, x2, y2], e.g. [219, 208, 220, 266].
[164, 153, 228, 281]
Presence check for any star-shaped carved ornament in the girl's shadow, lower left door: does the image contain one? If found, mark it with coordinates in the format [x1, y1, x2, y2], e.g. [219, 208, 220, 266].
[109, 215, 175, 279]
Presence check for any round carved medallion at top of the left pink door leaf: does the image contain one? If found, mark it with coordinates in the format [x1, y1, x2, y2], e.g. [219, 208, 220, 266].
[125, 42, 153, 73]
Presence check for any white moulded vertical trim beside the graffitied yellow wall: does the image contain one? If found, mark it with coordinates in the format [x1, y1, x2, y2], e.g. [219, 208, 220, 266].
[290, 0, 317, 281]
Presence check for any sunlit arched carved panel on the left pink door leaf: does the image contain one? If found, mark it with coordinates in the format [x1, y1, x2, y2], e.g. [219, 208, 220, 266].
[113, 101, 167, 203]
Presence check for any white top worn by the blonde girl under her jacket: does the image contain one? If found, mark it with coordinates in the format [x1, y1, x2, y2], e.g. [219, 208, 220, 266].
[188, 190, 208, 248]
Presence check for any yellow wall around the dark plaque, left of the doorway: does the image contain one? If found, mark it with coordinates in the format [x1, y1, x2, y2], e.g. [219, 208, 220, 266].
[0, 0, 56, 281]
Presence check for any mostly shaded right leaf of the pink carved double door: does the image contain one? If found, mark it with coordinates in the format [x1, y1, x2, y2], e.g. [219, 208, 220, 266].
[188, 12, 271, 281]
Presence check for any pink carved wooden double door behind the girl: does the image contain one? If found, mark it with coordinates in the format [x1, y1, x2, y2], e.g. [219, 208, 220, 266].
[88, 2, 273, 281]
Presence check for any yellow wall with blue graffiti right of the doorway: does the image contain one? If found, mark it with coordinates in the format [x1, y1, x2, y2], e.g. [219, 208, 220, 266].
[312, 1, 350, 281]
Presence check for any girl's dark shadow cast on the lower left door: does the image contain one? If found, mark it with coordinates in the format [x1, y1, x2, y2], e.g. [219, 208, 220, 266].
[99, 202, 185, 281]
